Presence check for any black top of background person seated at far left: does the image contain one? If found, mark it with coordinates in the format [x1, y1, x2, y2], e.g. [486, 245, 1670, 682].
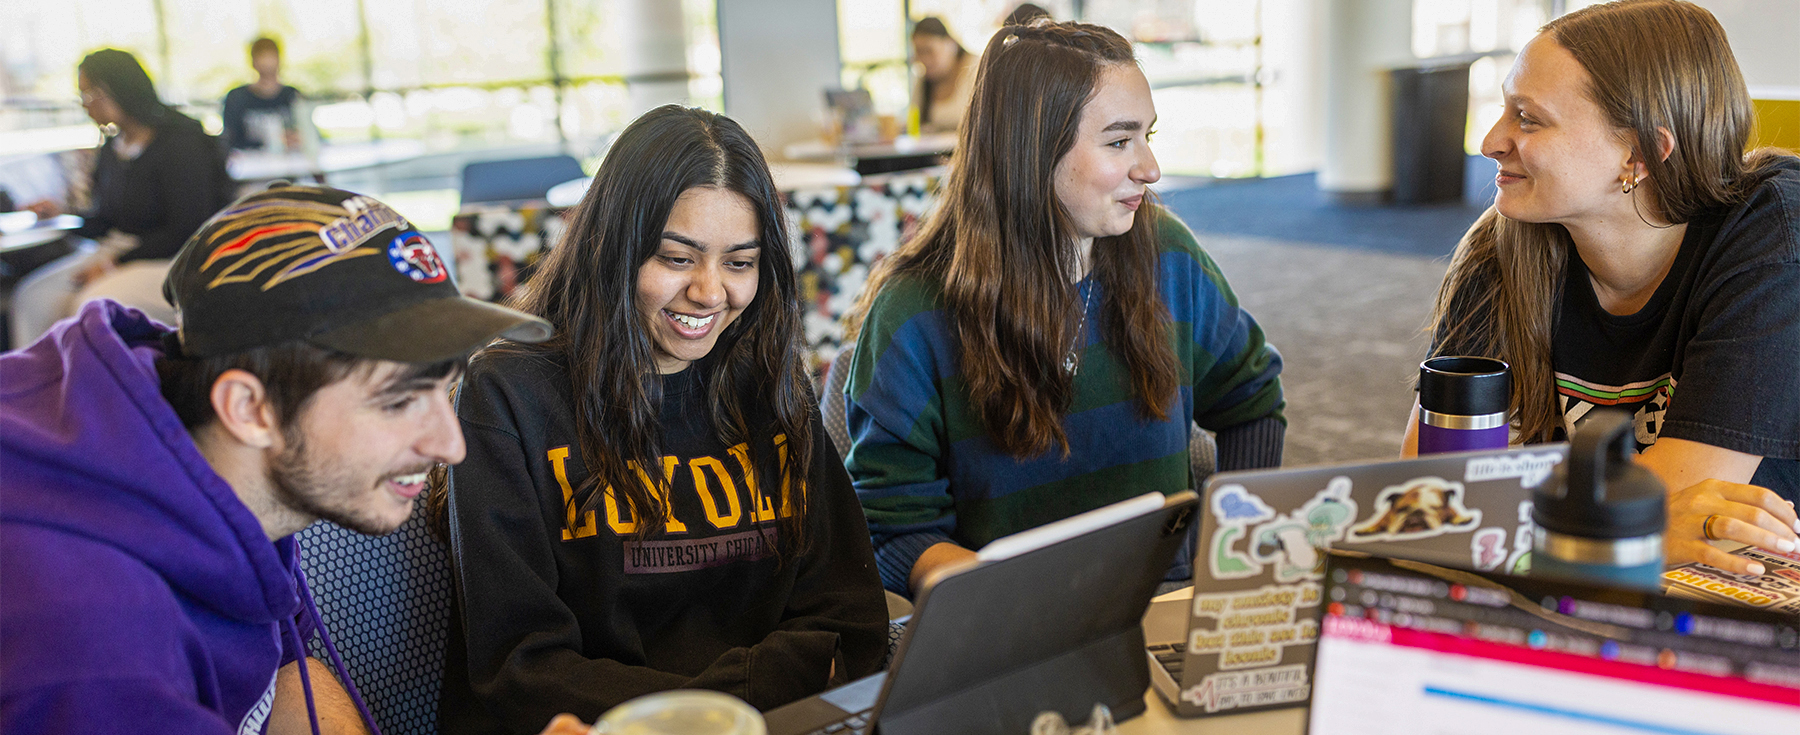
[119, 130, 227, 263]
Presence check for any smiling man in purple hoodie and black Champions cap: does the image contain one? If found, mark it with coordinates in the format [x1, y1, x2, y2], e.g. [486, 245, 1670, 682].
[0, 186, 590, 735]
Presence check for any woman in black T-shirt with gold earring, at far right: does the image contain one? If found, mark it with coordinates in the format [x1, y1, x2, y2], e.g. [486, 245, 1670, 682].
[1408, 0, 1800, 573]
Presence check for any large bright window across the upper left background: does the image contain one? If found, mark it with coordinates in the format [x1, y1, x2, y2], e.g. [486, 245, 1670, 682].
[0, 0, 722, 153]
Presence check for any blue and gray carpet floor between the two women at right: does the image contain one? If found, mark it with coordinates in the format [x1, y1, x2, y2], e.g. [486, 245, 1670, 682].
[1157, 157, 1494, 467]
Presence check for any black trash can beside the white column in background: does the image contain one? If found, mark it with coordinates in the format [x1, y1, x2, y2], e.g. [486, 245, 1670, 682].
[1390, 59, 1471, 204]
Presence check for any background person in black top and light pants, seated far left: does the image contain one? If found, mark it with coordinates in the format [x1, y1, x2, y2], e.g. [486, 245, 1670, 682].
[13, 49, 234, 348]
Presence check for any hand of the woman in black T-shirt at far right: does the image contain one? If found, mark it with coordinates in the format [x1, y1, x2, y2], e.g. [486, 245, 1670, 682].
[1663, 479, 1800, 575]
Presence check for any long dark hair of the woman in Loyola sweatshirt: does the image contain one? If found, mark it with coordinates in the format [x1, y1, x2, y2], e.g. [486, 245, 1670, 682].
[490, 104, 817, 551]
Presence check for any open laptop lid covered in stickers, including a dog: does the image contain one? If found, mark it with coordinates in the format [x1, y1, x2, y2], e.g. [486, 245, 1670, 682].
[1147, 443, 1568, 717]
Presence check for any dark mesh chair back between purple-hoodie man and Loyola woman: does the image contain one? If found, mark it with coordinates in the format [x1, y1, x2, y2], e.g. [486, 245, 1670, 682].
[299, 512, 452, 735]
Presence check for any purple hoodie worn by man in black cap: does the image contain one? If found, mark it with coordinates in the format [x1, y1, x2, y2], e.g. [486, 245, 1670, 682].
[0, 301, 373, 735]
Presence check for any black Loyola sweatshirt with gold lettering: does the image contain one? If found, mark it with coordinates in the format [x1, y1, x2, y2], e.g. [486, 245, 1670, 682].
[439, 353, 887, 735]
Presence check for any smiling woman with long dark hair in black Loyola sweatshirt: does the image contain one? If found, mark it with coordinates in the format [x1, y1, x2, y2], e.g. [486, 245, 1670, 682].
[434, 104, 887, 735]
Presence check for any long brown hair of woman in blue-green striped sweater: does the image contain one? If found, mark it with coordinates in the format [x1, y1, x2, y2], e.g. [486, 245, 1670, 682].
[846, 20, 1177, 458]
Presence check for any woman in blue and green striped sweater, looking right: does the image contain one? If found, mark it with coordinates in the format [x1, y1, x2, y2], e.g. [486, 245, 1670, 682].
[844, 23, 1285, 594]
